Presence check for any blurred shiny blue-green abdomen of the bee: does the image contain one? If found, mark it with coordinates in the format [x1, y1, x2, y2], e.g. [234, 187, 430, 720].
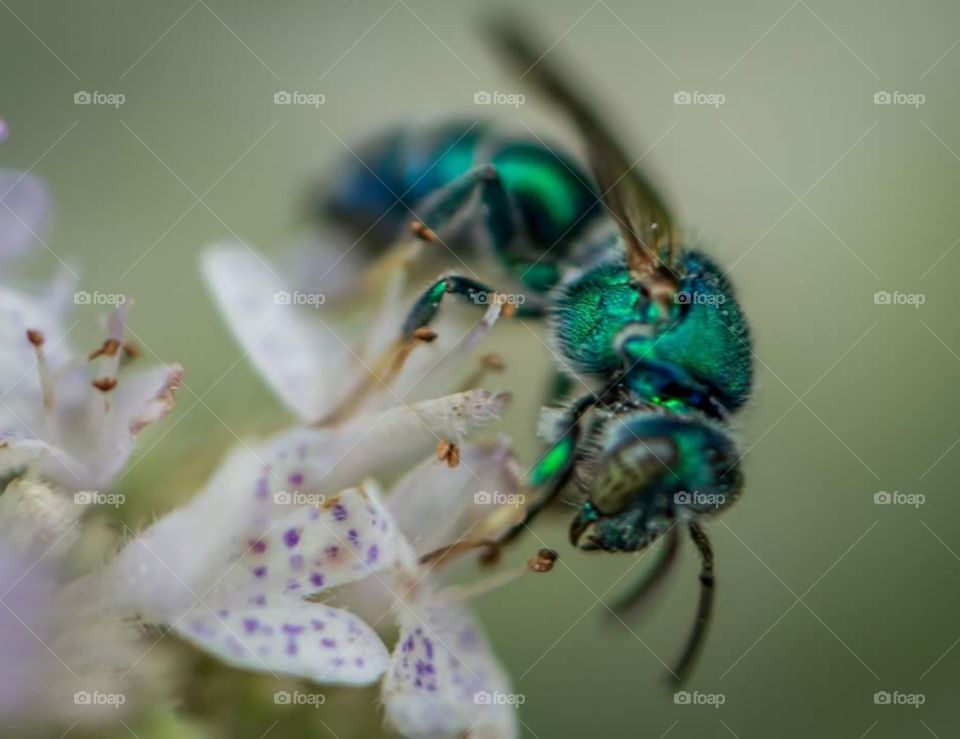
[317, 122, 601, 293]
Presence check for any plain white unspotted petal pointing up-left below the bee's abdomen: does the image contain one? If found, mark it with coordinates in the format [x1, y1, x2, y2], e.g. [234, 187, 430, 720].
[203, 243, 350, 420]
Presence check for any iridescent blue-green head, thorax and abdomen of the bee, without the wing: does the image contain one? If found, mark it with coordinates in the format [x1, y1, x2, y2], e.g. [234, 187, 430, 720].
[323, 122, 753, 549]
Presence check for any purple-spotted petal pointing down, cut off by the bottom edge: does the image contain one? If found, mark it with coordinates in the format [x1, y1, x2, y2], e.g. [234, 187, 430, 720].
[382, 595, 517, 739]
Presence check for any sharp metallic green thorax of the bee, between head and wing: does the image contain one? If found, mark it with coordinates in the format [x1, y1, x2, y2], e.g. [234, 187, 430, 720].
[551, 249, 753, 410]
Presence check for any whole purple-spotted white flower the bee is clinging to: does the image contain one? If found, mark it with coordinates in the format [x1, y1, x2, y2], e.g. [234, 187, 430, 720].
[87, 238, 517, 739]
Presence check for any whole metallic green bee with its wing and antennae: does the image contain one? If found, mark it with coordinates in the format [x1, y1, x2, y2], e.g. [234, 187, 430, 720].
[319, 21, 753, 682]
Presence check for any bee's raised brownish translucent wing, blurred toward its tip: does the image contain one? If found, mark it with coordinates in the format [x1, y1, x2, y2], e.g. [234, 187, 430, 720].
[490, 16, 674, 278]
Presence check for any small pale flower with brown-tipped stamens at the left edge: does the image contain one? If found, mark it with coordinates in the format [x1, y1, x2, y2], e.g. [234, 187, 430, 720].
[0, 264, 183, 490]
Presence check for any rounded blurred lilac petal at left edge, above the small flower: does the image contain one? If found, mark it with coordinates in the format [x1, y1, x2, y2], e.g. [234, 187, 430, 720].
[0, 169, 50, 262]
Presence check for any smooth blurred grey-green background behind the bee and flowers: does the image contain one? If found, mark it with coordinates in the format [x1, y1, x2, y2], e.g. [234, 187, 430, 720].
[0, 0, 960, 739]
